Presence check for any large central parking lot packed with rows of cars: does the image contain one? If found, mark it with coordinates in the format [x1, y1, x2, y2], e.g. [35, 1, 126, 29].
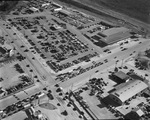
[9, 11, 98, 72]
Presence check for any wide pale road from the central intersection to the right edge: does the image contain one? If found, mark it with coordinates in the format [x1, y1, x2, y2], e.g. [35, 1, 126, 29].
[60, 40, 150, 90]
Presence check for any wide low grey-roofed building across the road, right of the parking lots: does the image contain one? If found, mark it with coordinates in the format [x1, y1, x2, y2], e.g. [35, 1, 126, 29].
[99, 27, 131, 45]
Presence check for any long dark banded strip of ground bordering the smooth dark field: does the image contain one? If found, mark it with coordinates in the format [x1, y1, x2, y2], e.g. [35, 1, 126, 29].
[56, 0, 150, 37]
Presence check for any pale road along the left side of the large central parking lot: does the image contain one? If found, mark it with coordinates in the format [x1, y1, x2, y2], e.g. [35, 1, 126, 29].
[0, 22, 53, 84]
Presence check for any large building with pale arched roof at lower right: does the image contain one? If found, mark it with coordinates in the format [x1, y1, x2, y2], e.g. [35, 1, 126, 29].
[109, 80, 148, 105]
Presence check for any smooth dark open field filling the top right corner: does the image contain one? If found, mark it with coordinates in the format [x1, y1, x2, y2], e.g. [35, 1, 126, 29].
[75, 0, 150, 24]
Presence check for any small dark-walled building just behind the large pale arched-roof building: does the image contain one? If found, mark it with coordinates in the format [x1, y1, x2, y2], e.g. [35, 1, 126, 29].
[113, 71, 130, 83]
